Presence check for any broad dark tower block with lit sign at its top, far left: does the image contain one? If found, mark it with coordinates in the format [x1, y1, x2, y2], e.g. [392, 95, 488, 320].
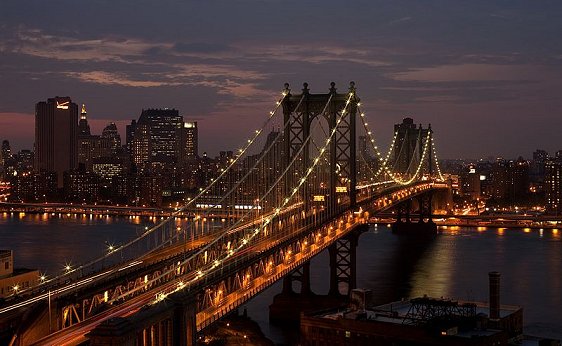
[35, 96, 78, 188]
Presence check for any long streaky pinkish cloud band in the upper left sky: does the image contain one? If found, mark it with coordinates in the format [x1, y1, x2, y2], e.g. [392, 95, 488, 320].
[0, 28, 276, 97]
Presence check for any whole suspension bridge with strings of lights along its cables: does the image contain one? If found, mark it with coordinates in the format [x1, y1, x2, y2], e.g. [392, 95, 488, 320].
[0, 82, 448, 345]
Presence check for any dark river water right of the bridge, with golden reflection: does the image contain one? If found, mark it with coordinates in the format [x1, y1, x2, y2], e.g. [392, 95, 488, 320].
[247, 225, 562, 343]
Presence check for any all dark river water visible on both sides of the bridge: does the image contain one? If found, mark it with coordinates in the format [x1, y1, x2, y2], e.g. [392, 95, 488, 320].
[0, 213, 562, 343]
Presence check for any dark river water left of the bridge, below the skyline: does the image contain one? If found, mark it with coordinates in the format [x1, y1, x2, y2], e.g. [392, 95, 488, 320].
[0, 213, 144, 276]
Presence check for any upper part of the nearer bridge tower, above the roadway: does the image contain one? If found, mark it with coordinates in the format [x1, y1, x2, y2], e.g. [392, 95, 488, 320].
[282, 82, 359, 210]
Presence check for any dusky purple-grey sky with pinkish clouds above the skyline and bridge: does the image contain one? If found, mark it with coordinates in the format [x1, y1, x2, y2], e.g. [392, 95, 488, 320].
[0, 0, 562, 159]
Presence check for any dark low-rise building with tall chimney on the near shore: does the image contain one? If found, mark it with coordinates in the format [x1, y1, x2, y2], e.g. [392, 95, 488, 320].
[300, 272, 523, 346]
